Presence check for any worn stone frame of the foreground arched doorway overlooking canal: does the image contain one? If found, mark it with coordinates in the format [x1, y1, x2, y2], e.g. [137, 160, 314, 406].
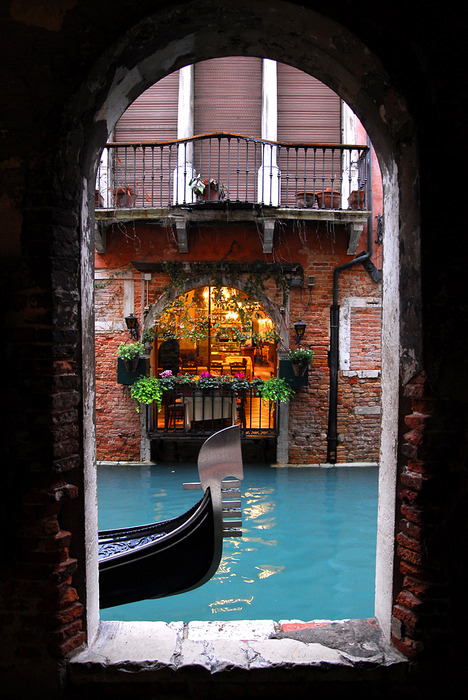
[74, 2, 420, 652]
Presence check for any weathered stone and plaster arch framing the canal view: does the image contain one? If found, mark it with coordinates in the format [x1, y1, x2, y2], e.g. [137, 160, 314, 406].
[63, 0, 421, 656]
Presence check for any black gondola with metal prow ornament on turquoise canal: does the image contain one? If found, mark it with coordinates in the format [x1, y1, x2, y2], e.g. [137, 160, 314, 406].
[98, 425, 243, 608]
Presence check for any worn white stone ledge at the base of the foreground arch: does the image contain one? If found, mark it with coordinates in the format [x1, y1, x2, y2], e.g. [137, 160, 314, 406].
[68, 619, 407, 686]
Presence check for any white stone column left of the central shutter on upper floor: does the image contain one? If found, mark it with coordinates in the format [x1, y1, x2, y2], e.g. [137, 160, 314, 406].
[173, 65, 195, 204]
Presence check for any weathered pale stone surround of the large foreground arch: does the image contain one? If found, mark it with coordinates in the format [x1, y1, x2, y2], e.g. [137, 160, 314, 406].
[74, 3, 419, 660]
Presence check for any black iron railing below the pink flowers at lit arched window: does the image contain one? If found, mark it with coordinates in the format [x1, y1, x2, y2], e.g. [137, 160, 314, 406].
[146, 385, 279, 437]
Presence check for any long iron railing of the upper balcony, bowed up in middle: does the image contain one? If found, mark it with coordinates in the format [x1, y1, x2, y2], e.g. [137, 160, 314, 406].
[96, 133, 369, 210]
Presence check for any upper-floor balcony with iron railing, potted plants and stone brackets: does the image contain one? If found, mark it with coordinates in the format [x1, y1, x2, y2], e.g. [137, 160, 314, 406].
[95, 133, 370, 255]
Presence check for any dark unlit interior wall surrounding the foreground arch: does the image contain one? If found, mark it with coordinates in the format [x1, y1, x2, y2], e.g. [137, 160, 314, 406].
[0, 0, 468, 697]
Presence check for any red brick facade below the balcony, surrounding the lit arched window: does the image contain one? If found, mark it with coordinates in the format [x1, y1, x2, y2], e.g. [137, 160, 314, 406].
[95, 222, 381, 464]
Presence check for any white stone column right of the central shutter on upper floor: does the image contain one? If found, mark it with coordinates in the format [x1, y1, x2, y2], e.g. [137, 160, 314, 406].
[257, 58, 281, 207]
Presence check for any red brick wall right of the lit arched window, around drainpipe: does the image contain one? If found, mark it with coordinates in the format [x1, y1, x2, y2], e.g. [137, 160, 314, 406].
[289, 246, 381, 464]
